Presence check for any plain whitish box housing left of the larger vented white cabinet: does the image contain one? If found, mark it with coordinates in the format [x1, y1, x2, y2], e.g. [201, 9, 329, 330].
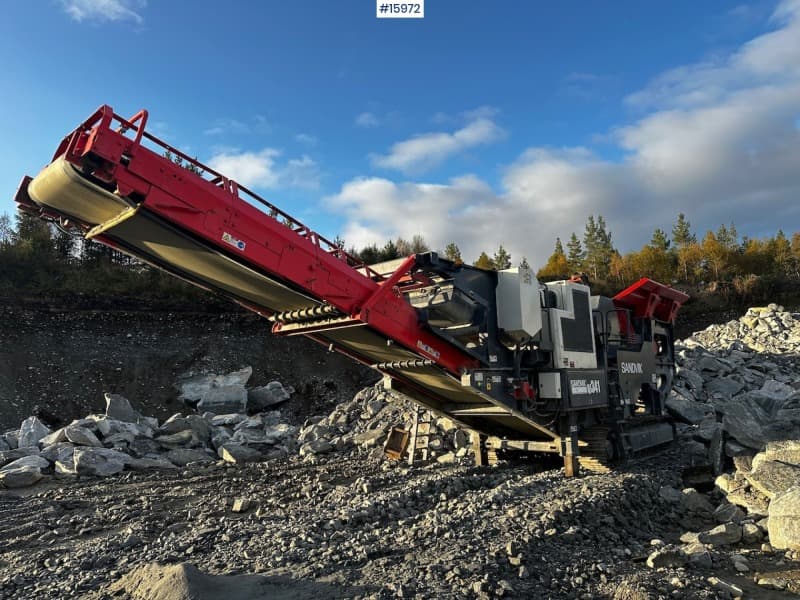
[497, 267, 542, 342]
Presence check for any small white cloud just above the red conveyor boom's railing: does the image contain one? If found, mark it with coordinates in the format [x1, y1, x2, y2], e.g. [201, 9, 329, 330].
[208, 148, 320, 189]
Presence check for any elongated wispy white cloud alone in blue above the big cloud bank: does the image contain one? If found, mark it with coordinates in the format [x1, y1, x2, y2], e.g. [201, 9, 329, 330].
[372, 117, 505, 173]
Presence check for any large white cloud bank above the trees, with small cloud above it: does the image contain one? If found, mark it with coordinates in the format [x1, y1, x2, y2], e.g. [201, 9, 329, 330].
[328, 0, 800, 265]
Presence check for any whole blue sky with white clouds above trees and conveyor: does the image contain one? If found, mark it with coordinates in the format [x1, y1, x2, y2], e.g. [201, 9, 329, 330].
[0, 0, 800, 264]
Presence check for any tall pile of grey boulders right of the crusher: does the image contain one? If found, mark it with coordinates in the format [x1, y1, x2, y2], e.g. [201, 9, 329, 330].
[651, 304, 800, 595]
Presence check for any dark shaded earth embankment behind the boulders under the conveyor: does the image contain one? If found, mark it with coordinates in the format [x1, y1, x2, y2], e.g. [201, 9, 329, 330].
[0, 305, 376, 430]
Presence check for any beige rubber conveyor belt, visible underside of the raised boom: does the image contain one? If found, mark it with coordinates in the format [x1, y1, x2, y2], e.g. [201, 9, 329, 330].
[28, 157, 555, 439]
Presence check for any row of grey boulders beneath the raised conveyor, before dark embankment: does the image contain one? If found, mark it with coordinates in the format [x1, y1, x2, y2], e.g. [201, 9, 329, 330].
[0, 378, 297, 488]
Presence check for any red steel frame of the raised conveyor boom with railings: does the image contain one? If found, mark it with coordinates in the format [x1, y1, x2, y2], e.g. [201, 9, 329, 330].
[18, 106, 476, 376]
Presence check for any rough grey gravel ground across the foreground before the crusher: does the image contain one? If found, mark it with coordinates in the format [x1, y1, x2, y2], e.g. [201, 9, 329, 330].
[0, 451, 800, 600]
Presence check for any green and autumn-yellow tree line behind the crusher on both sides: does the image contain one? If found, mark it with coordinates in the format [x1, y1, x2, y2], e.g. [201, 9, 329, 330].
[0, 207, 800, 304]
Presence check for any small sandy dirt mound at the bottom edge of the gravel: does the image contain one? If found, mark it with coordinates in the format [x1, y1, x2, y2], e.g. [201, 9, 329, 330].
[108, 563, 353, 600]
